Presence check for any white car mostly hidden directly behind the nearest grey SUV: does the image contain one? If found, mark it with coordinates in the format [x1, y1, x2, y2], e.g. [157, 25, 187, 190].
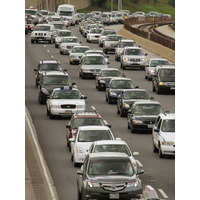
[88, 140, 139, 172]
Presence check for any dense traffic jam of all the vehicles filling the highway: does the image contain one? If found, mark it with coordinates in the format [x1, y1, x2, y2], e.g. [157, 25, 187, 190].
[25, 4, 175, 200]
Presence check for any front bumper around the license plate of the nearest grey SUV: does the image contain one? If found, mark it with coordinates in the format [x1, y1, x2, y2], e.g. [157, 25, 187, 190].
[84, 188, 142, 200]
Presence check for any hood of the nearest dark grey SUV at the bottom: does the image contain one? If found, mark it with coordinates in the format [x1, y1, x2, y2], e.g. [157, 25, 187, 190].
[90, 175, 136, 184]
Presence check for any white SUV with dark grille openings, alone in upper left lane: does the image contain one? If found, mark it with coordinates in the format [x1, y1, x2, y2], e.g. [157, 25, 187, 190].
[31, 24, 56, 44]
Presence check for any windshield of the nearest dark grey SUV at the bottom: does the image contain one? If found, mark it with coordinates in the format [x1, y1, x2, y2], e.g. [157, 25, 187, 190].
[88, 158, 134, 176]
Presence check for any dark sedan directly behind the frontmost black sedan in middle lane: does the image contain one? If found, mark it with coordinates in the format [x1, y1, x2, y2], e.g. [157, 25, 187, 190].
[117, 89, 154, 117]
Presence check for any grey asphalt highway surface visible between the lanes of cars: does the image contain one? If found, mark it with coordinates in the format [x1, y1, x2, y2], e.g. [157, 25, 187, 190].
[25, 25, 175, 200]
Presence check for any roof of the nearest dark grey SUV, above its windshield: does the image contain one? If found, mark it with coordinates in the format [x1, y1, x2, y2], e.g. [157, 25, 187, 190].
[89, 152, 129, 159]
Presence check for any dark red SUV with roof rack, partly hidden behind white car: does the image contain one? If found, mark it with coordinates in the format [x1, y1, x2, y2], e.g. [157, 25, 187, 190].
[66, 109, 111, 151]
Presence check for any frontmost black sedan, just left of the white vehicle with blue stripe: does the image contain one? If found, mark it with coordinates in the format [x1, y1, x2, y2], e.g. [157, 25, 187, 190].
[127, 101, 164, 133]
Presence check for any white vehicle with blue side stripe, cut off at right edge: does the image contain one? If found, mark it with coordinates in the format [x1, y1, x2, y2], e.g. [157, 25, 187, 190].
[152, 113, 175, 158]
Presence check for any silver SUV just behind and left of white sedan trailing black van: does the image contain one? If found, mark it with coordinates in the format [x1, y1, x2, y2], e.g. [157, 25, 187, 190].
[121, 47, 147, 70]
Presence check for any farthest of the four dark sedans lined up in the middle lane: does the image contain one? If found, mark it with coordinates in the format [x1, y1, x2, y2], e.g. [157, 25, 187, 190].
[95, 68, 125, 90]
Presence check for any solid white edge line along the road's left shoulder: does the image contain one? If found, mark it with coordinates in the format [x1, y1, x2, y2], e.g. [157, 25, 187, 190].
[25, 111, 56, 199]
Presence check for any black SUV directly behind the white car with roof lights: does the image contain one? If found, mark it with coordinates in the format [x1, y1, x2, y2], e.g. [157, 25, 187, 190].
[38, 72, 75, 104]
